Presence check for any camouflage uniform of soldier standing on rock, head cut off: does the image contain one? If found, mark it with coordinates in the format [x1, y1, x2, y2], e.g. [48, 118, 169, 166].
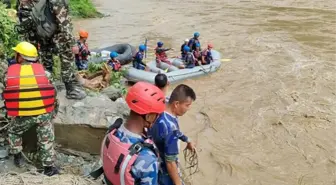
[17, 0, 86, 99]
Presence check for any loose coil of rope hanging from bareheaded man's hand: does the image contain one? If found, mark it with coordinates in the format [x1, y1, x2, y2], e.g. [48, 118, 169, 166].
[183, 148, 199, 176]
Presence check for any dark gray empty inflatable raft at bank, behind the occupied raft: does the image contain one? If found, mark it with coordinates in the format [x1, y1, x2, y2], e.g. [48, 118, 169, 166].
[89, 44, 136, 65]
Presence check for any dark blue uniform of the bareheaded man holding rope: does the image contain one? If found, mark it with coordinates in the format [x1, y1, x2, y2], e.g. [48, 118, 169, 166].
[149, 112, 188, 185]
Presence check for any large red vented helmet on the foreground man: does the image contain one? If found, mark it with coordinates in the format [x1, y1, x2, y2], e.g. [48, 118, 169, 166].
[126, 82, 165, 115]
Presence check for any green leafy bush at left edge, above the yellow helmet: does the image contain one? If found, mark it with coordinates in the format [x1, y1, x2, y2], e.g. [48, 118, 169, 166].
[0, 3, 19, 58]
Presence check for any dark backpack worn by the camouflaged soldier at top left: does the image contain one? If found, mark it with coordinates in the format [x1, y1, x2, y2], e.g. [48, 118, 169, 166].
[31, 0, 69, 39]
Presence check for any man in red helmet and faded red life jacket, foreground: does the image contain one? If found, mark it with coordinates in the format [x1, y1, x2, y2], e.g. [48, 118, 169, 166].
[91, 82, 165, 185]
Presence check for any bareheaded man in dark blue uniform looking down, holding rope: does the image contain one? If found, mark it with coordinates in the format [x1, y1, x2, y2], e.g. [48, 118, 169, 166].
[149, 84, 196, 185]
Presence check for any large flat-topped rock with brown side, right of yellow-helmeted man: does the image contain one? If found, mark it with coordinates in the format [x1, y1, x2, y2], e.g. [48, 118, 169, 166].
[53, 91, 129, 154]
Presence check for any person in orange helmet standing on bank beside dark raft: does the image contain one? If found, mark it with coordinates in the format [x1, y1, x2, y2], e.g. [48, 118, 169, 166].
[72, 30, 90, 71]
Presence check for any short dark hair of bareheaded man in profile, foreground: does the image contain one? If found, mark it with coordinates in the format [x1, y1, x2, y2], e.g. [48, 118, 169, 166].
[169, 84, 196, 104]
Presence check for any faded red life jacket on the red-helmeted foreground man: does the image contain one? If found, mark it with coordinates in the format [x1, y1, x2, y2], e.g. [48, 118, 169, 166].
[90, 118, 159, 185]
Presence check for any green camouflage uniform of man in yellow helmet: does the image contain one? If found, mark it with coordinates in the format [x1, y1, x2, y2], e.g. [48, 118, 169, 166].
[0, 62, 59, 166]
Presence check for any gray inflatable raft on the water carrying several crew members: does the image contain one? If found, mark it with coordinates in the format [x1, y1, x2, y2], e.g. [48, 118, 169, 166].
[125, 50, 221, 84]
